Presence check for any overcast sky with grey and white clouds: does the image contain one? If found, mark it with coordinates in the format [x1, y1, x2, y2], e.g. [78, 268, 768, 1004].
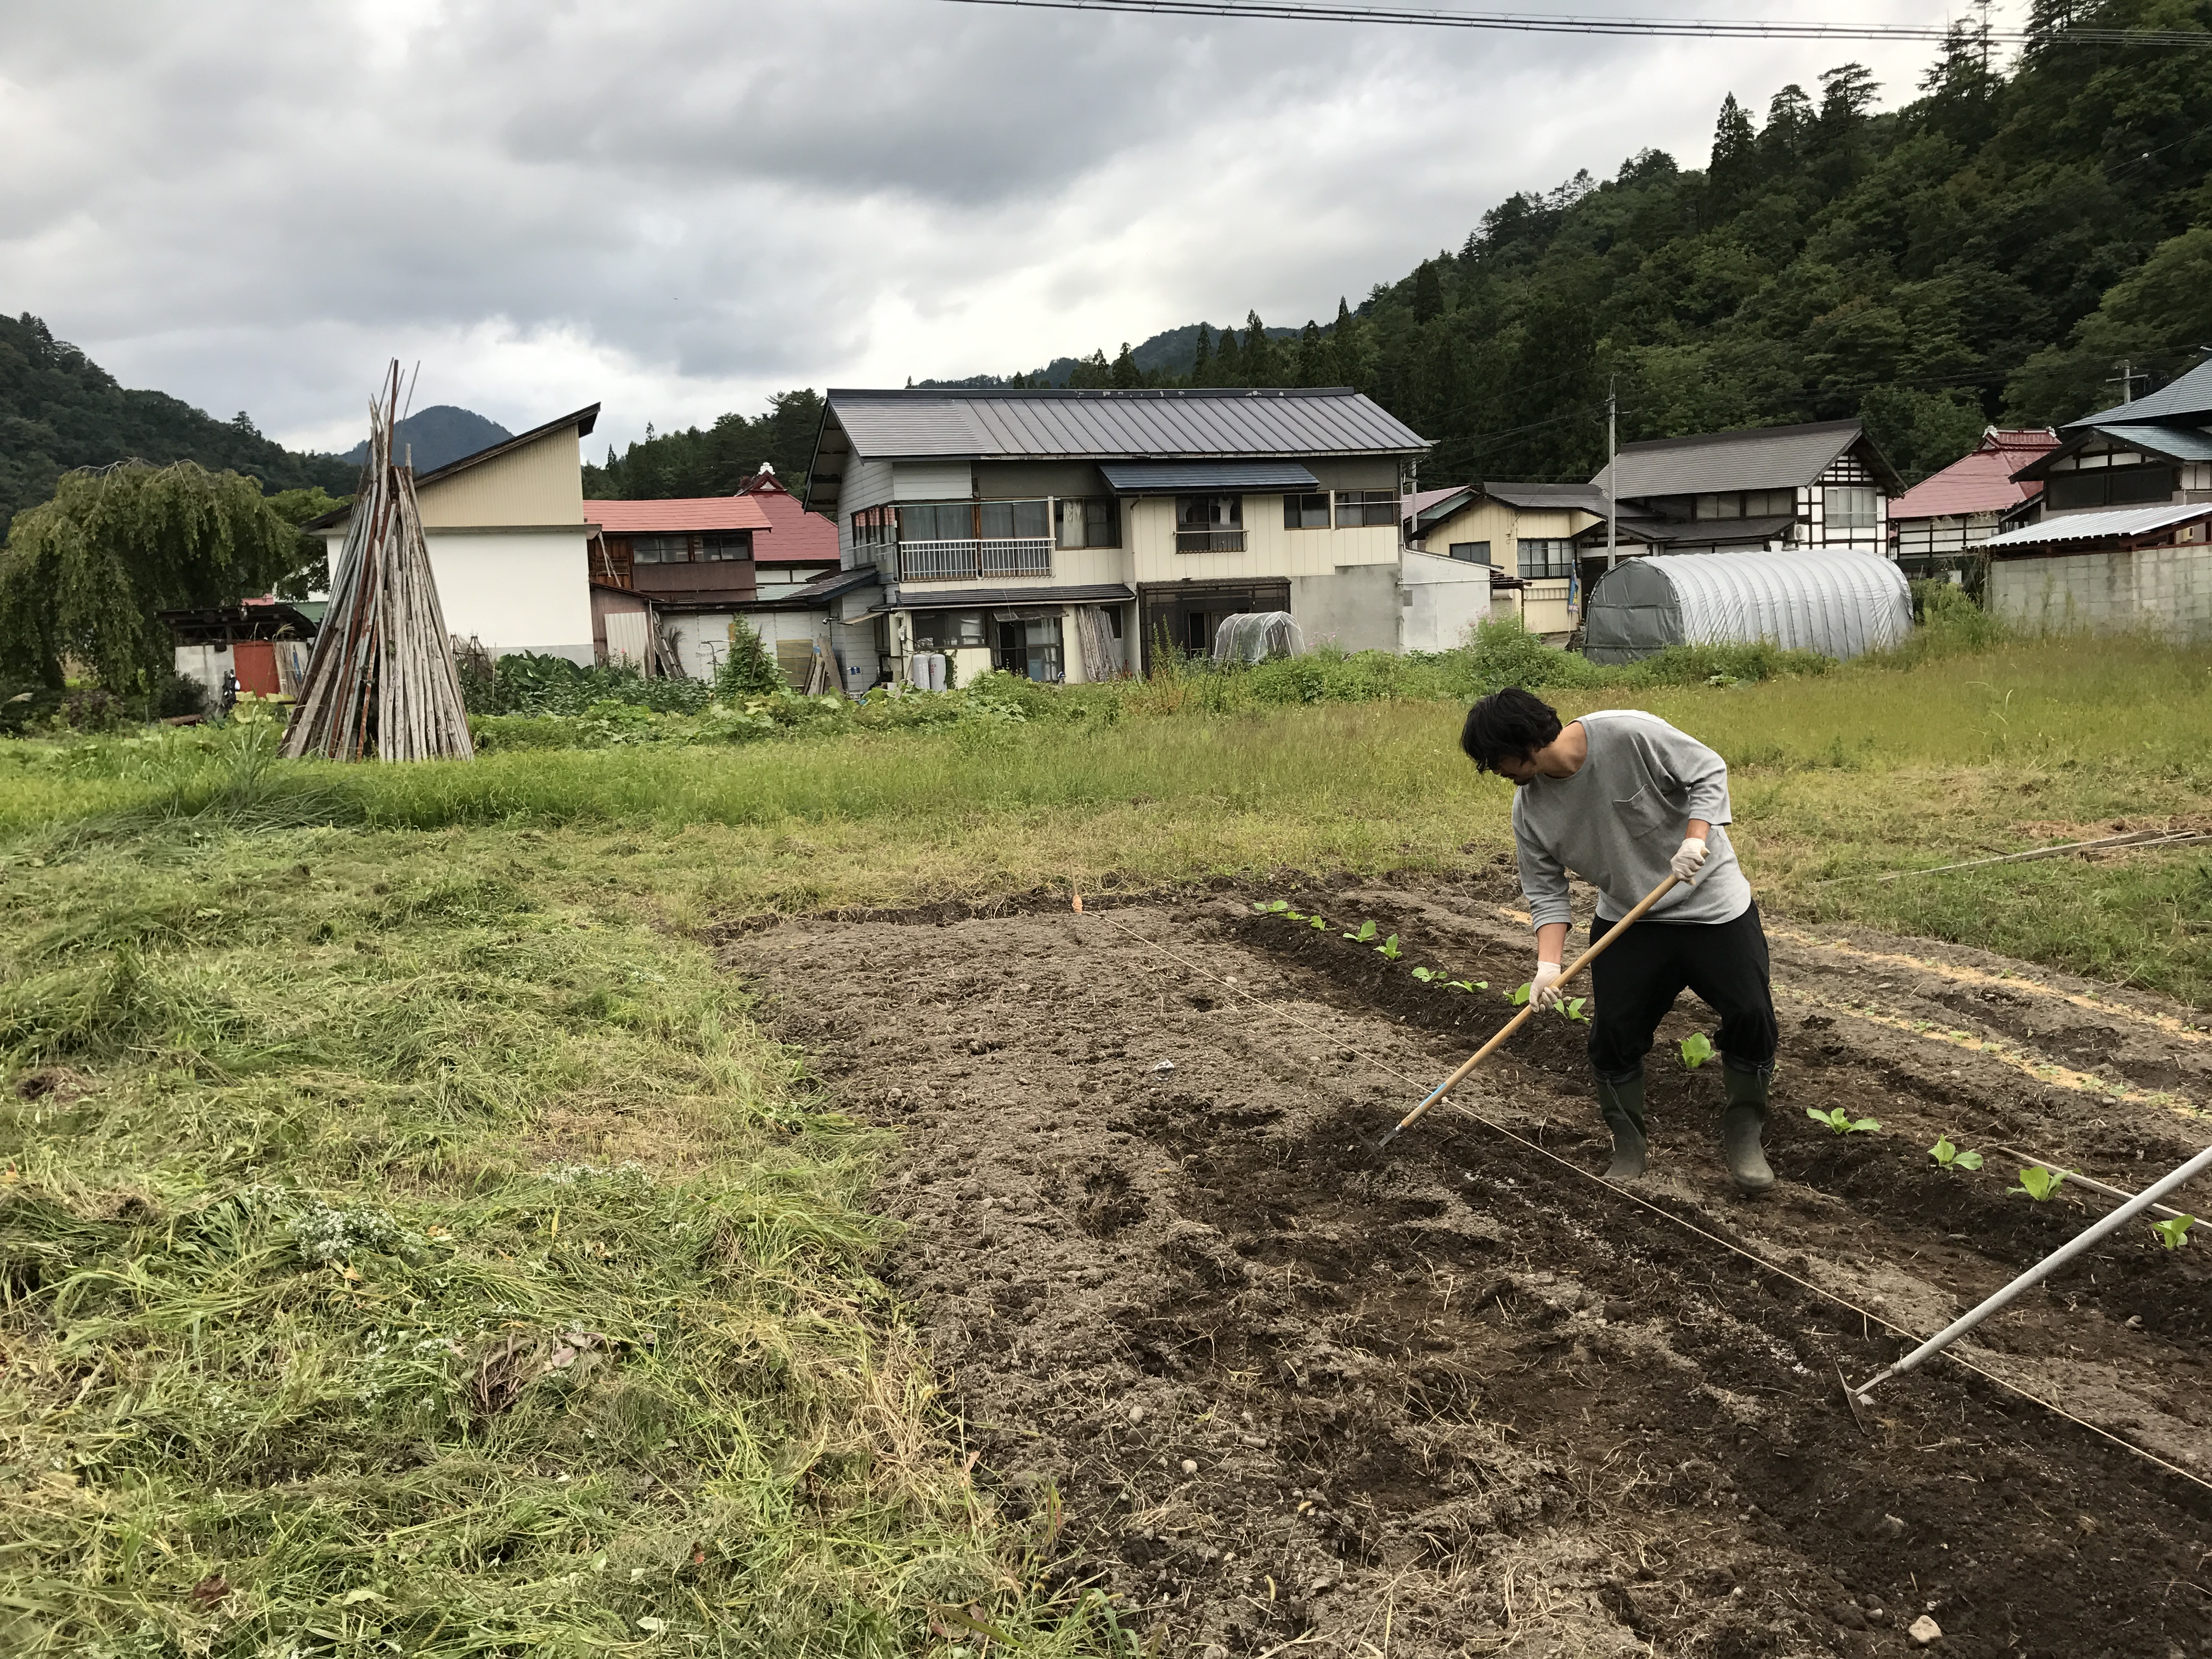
[0, 0, 1999, 452]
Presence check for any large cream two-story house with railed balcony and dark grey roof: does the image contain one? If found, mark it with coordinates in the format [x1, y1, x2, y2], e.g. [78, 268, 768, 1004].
[808, 387, 1427, 684]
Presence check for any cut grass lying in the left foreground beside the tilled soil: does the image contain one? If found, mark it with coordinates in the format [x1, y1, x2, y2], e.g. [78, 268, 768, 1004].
[0, 830, 1091, 1655]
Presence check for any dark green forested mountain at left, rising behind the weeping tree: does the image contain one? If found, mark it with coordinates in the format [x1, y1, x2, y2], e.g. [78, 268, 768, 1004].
[0, 312, 354, 538]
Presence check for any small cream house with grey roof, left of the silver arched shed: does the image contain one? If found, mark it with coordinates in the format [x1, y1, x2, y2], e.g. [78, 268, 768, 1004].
[1404, 484, 1606, 639]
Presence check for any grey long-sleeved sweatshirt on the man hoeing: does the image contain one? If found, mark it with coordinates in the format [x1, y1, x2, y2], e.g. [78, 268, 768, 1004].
[1513, 708, 1752, 927]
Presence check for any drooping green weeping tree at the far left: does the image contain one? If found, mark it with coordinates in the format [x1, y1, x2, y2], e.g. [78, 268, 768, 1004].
[0, 460, 298, 695]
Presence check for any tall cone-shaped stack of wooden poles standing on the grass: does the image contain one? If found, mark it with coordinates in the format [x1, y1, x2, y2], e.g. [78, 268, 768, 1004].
[283, 363, 476, 761]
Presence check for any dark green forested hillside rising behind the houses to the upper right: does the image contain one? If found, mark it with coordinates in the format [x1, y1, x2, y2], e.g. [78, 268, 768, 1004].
[586, 0, 2212, 495]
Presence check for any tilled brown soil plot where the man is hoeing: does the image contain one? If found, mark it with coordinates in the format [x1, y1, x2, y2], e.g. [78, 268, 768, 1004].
[725, 883, 2212, 1659]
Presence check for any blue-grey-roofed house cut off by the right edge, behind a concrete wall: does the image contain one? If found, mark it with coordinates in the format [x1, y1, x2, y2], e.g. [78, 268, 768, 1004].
[1982, 360, 2212, 637]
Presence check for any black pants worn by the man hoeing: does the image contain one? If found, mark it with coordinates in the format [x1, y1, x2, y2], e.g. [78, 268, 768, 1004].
[1590, 905, 1779, 1082]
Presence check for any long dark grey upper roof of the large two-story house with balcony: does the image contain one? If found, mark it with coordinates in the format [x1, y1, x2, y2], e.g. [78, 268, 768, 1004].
[827, 387, 1429, 460]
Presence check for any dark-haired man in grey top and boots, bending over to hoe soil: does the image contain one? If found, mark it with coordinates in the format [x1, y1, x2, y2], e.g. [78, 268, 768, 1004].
[1460, 686, 1776, 1192]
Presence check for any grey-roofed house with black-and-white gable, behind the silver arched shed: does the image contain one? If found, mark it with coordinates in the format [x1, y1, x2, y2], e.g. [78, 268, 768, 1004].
[1575, 420, 1905, 584]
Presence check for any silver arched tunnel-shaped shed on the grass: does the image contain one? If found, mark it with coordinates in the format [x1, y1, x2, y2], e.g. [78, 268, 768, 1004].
[1582, 551, 1914, 664]
